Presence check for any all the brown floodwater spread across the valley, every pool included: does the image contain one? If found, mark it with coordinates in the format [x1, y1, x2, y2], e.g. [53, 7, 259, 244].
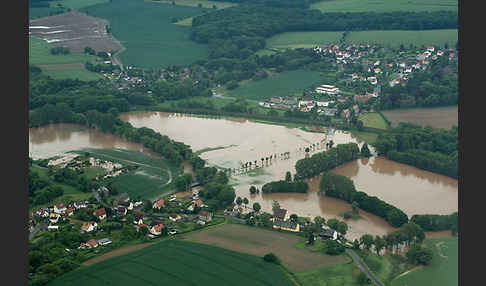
[29, 112, 458, 239]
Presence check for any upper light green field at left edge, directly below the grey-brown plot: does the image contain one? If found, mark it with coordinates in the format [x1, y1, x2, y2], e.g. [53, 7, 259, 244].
[29, 37, 96, 65]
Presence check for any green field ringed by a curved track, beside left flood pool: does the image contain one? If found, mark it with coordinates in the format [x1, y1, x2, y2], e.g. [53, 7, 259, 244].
[77, 148, 179, 199]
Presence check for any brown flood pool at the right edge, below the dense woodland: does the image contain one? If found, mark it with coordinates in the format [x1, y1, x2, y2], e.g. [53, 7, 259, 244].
[333, 157, 458, 217]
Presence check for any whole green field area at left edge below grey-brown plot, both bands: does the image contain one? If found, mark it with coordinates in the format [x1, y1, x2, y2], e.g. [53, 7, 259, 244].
[29, 37, 103, 81]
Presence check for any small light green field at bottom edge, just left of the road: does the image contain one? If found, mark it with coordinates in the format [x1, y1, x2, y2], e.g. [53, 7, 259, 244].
[295, 261, 359, 286]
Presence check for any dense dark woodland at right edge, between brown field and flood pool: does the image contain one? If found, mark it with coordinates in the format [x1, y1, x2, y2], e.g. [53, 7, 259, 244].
[375, 123, 459, 179]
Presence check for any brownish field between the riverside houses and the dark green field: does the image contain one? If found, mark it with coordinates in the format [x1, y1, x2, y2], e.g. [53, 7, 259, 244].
[184, 224, 350, 272]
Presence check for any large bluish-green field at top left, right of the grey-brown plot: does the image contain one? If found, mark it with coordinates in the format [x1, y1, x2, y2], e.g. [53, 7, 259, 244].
[80, 0, 208, 68]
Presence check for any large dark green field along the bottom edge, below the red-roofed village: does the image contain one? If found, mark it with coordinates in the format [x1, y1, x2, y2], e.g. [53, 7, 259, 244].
[48, 240, 294, 286]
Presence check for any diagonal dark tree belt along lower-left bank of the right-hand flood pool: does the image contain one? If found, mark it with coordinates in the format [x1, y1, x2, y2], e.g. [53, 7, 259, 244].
[319, 172, 408, 227]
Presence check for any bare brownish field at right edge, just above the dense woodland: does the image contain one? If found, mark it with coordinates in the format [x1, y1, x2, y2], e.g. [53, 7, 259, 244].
[381, 106, 459, 129]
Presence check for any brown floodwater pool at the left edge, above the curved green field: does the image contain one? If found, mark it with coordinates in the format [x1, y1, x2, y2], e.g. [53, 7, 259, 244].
[29, 124, 145, 159]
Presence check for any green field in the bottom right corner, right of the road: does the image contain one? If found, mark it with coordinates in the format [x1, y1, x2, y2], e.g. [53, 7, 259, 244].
[391, 237, 459, 286]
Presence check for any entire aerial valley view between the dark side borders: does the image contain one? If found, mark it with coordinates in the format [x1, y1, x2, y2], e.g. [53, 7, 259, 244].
[26, 0, 460, 286]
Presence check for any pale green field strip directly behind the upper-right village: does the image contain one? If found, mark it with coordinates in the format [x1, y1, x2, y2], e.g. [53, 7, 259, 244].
[260, 29, 458, 50]
